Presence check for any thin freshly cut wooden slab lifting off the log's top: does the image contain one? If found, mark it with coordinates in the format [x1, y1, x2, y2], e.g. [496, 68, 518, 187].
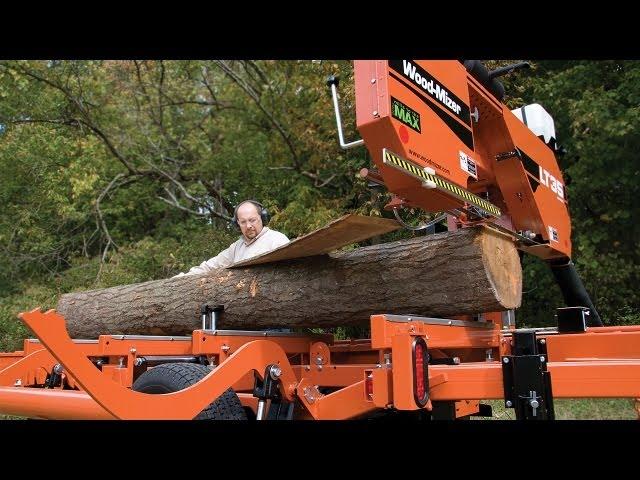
[229, 214, 400, 268]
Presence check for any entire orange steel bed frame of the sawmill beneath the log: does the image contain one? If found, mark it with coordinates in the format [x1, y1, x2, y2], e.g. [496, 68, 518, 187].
[0, 310, 640, 419]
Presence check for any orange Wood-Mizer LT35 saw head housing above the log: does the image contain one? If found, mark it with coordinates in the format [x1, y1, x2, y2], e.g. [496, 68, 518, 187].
[354, 60, 571, 259]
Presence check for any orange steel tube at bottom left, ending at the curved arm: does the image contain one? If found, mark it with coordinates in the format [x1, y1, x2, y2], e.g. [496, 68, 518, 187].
[0, 387, 114, 420]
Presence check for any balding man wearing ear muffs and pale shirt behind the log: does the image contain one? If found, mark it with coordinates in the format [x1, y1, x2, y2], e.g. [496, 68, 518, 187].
[176, 200, 289, 277]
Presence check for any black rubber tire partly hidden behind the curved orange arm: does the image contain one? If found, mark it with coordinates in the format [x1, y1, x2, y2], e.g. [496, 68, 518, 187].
[132, 363, 247, 420]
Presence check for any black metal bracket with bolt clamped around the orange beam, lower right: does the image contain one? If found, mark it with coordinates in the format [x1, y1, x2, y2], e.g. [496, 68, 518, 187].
[502, 330, 555, 420]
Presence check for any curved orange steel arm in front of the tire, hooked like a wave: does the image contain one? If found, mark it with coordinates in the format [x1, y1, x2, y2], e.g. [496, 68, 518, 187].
[20, 310, 297, 419]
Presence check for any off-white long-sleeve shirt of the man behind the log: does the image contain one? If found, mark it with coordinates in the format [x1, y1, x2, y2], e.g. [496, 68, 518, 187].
[176, 227, 289, 277]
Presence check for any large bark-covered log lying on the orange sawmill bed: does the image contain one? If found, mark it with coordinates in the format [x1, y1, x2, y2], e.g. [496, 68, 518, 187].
[57, 227, 522, 338]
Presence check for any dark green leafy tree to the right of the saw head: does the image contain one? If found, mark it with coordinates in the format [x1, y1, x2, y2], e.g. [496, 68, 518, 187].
[516, 60, 640, 325]
